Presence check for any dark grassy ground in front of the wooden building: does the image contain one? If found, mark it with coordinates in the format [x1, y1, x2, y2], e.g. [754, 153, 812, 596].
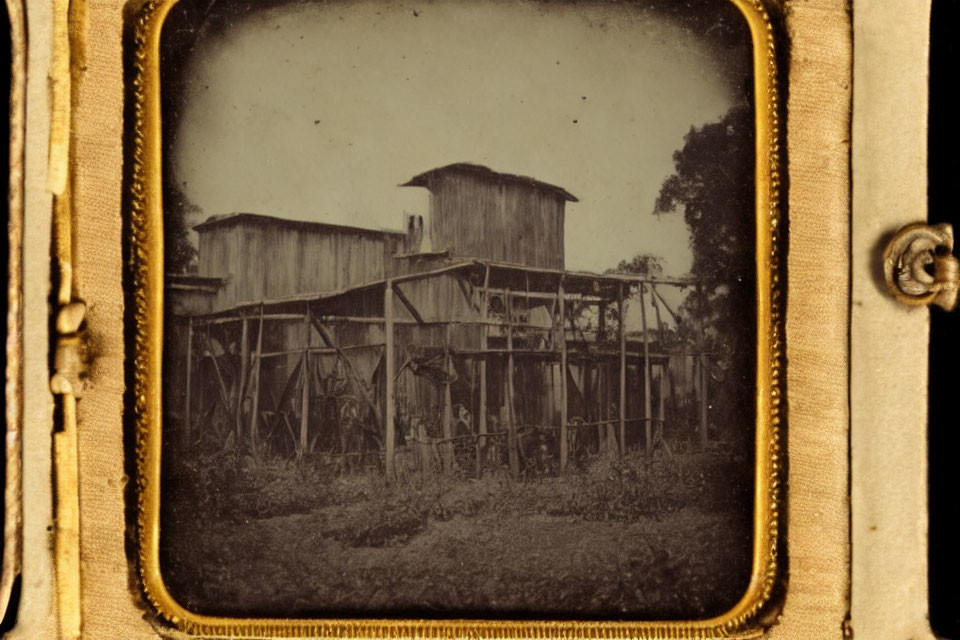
[162, 444, 752, 619]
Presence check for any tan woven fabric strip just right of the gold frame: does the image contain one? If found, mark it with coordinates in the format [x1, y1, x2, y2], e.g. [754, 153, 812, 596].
[770, 1, 852, 639]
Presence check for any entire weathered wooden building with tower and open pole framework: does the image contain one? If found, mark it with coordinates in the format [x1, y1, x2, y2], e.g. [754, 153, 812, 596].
[165, 165, 707, 478]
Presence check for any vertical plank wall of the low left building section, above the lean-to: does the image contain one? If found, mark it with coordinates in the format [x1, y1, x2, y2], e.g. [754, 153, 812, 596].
[199, 219, 403, 309]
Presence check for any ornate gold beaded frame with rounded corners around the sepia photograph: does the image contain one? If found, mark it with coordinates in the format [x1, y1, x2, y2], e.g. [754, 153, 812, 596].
[129, 0, 784, 640]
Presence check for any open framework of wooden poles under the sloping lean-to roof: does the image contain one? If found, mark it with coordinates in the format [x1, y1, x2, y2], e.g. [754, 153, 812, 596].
[167, 260, 709, 479]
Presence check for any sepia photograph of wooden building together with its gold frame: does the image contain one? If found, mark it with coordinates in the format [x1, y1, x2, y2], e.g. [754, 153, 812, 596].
[126, 0, 784, 638]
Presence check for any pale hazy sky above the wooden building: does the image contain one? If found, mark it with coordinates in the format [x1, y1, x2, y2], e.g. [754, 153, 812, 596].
[167, 0, 738, 276]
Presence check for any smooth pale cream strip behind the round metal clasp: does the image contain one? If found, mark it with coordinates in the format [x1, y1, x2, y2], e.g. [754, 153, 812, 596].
[850, 0, 933, 640]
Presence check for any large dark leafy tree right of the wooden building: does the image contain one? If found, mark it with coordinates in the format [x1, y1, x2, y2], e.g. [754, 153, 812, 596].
[653, 104, 756, 444]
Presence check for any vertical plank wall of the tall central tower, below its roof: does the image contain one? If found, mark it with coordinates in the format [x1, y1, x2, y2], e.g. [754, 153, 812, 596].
[429, 172, 565, 269]
